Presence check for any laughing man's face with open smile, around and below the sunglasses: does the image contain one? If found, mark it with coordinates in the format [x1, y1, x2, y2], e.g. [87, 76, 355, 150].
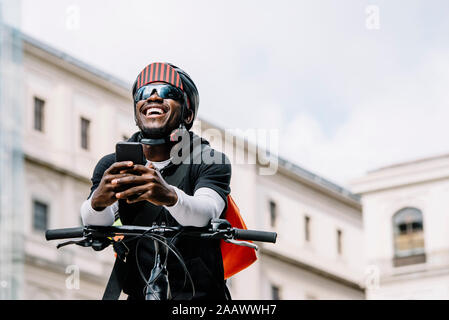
[136, 82, 185, 139]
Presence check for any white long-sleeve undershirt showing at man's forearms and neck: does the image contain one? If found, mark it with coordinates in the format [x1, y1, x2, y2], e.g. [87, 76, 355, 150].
[80, 159, 225, 227]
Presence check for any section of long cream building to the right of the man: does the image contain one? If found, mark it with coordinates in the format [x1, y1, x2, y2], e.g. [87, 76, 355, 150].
[193, 121, 365, 300]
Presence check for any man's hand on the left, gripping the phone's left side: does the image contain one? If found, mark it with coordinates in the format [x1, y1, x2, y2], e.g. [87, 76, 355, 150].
[91, 161, 133, 211]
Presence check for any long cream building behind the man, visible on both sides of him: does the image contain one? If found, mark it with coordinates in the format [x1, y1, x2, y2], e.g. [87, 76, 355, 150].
[0, 30, 364, 299]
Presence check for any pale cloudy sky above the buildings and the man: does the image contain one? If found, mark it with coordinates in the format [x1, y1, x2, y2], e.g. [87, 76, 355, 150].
[14, 0, 449, 187]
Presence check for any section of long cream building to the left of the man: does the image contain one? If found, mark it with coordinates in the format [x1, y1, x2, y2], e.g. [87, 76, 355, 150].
[22, 31, 134, 299]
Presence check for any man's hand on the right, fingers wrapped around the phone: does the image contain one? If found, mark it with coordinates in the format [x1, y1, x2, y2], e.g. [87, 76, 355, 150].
[111, 163, 178, 206]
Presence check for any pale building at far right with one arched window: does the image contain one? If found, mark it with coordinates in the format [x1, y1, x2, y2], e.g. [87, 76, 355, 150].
[351, 155, 449, 299]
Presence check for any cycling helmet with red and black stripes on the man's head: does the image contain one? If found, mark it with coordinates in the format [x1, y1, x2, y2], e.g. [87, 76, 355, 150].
[132, 62, 200, 130]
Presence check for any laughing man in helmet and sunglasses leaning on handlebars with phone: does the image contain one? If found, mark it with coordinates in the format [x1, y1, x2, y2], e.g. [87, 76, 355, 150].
[81, 63, 231, 299]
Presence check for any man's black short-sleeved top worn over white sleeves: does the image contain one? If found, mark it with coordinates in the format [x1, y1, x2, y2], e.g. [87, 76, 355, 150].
[89, 132, 231, 299]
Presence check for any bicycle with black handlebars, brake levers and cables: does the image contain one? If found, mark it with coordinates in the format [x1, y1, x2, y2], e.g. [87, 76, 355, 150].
[45, 219, 277, 300]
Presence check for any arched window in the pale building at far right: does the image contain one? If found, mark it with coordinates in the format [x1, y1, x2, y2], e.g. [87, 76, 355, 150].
[393, 208, 425, 266]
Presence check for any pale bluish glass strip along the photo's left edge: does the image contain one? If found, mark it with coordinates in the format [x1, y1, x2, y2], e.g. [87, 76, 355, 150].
[0, 0, 26, 299]
